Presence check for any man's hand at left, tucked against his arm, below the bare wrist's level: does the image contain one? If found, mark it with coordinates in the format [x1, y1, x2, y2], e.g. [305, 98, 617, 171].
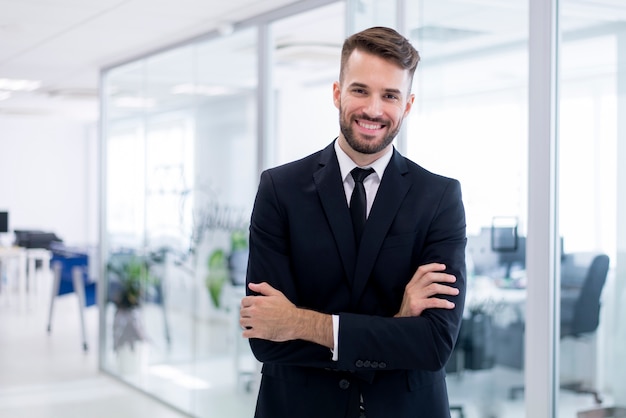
[239, 283, 298, 342]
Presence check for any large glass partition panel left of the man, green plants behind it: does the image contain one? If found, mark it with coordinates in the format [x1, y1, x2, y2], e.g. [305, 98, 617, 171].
[101, 28, 258, 417]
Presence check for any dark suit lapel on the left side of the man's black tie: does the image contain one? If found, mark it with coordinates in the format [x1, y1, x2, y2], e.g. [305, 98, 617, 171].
[313, 143, 356, 281]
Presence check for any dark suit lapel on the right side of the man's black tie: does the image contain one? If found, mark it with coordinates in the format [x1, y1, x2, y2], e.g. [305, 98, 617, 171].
[348, 149, 411, 309]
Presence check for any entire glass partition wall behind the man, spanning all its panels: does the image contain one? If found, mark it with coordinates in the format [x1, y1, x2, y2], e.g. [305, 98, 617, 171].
[100, 0, 626, 418]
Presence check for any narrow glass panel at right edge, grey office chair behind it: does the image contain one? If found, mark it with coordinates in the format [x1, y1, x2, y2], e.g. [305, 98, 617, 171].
[557, 0, 626, 418]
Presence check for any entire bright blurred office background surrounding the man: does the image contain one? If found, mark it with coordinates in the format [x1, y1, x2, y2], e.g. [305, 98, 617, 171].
[0, 0, 626, 418]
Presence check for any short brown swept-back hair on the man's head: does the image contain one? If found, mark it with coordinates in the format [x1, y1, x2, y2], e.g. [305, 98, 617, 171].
[339, 26, 420, 85]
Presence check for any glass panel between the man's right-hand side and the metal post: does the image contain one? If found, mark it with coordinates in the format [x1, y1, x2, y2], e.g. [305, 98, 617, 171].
[405, 0, 528, 418]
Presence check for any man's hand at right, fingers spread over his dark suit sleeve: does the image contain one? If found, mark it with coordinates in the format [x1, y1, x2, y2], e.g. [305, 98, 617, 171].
[395, 263, 459, 317]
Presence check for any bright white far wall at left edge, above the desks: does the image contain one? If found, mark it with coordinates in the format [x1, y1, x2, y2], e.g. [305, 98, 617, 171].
[0, 116, 99, 245]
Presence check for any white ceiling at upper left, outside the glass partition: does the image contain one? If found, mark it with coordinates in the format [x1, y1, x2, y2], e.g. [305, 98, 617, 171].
[0, 0, 297, 120]
